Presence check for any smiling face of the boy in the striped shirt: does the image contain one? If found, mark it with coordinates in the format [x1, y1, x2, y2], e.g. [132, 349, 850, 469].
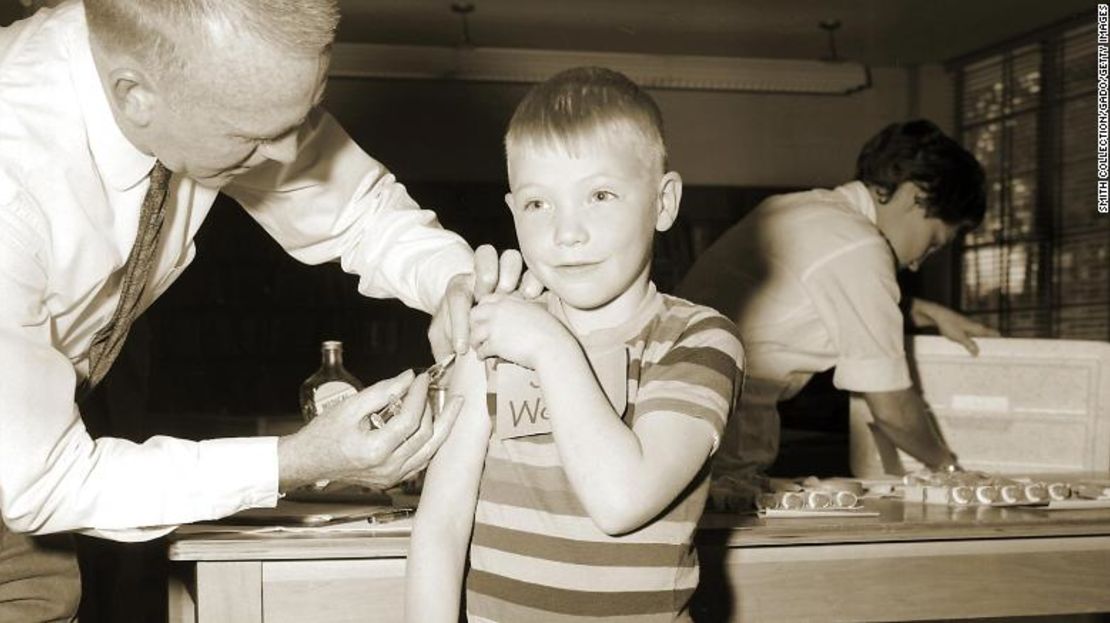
[505, 132, 682, 330]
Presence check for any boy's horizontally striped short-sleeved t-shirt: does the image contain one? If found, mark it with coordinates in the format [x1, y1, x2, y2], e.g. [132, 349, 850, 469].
[466, 287, 743, 623]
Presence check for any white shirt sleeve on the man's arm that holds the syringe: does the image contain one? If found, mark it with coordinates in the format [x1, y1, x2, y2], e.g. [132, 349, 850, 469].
[0, 189, 278, 540]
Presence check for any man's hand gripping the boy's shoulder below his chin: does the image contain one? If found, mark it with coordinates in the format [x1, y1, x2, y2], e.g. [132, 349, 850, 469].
[427, 244, 543, 361]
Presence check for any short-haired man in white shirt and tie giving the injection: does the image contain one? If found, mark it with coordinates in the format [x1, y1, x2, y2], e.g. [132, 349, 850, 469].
[0, 0, 519, 621]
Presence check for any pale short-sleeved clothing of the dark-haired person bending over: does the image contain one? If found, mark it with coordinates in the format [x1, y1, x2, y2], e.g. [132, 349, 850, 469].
[677, 181, 911, 471]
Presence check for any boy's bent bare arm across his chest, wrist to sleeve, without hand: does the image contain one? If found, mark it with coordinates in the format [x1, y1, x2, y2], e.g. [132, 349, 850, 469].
[536, 342, 714, 534]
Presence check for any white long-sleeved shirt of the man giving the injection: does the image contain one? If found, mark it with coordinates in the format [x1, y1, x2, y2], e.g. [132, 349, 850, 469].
[0, 2, 473, 539]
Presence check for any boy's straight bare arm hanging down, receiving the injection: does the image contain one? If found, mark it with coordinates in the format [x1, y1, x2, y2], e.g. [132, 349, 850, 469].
[405, 352, 491, 623]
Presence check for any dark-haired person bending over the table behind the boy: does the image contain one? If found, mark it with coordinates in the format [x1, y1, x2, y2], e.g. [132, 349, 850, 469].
[676, 120, 998, 506]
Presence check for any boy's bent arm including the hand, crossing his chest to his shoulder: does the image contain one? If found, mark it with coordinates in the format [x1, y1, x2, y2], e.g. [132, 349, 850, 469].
[471, 294, 743, 534]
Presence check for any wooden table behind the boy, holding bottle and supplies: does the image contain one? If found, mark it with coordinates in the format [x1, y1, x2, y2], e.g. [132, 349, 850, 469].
[169, 493, 1110, 623]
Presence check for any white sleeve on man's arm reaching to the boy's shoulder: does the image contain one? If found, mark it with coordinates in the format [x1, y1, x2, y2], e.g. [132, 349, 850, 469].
[224, 111, 474, 312]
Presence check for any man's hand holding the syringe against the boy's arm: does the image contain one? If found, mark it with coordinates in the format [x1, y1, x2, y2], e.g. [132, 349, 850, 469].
[278, 370, 462, 491]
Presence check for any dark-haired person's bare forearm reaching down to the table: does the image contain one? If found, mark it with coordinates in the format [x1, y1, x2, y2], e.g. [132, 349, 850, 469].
[864, 388, 956, 469]
